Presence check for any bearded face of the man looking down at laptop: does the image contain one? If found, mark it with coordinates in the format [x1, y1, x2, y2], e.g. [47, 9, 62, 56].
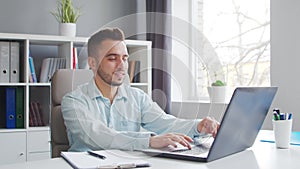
[96, 39, 128, 86]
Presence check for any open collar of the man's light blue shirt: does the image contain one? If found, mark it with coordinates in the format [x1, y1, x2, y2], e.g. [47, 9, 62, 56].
[87, 78, 128, 100]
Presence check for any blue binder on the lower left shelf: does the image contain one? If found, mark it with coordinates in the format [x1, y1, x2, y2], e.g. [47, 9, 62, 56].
[5, 87, 16, 128]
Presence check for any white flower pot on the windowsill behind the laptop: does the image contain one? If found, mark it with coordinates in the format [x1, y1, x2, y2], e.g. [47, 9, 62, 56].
[207, 86, 228, 103]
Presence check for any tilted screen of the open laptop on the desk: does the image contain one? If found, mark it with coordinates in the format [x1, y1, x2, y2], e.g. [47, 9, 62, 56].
[207, 87, 277, 161]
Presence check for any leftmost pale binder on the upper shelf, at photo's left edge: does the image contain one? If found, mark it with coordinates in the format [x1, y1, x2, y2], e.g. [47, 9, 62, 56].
[0, 41, 9, 83]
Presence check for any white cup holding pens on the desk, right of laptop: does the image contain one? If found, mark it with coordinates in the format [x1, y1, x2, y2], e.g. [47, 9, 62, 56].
[273, 119, 293, 148]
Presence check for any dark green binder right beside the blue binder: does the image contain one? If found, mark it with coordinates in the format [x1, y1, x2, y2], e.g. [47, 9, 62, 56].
[16, 87, 24, 128]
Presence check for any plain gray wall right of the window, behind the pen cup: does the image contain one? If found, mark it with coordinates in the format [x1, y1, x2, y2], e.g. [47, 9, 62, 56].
[269, 0, 300, 131]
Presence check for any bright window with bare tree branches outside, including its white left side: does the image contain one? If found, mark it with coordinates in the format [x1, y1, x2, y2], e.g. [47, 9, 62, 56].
[172, 0, 270, 101]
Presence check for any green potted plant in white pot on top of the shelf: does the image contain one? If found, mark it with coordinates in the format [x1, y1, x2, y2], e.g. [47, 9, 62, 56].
[51, 0, 81, 37]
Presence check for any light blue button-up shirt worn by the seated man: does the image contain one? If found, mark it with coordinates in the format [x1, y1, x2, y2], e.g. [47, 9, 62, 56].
[61, 79, 199, 151]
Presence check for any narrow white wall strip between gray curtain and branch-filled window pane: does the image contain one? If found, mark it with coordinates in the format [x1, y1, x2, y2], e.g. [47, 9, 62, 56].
[171, 0, 195, 101]
